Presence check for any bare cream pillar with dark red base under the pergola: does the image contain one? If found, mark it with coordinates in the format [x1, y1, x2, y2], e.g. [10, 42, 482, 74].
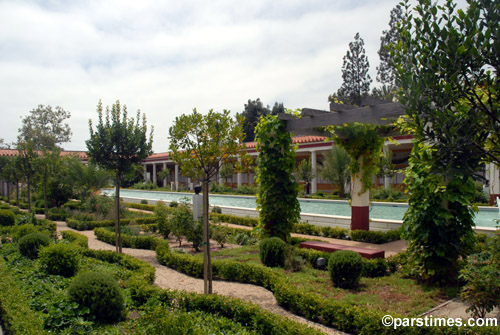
[351, 157, 370, 230]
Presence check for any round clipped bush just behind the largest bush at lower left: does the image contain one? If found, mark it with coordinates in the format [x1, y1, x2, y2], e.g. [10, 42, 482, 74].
[39, 243, 80, 277]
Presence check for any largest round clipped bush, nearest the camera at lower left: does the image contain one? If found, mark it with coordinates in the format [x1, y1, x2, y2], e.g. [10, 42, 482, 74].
[68, 272, 124, 323]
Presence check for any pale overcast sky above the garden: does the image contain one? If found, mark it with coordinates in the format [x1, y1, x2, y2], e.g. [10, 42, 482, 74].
[0, 0, 410, 152]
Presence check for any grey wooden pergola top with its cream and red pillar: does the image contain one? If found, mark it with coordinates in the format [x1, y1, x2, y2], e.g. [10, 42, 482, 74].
[278, 97, 406, 230]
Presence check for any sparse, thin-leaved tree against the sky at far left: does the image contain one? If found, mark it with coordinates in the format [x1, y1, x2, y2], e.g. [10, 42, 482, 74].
[19, 105, 71, 215]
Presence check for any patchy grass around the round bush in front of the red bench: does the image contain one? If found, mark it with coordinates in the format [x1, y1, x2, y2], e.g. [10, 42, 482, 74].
[201, 245, 447, 316]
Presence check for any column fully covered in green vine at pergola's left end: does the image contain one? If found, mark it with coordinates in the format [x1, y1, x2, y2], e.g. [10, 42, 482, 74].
[256, 116, 300, 241]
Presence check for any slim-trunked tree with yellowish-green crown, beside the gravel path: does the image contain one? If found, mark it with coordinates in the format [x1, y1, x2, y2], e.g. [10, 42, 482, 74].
[169, 109, 244, 294]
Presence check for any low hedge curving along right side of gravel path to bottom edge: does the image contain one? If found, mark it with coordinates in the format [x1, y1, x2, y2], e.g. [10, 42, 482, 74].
[156, 246, 498, 335]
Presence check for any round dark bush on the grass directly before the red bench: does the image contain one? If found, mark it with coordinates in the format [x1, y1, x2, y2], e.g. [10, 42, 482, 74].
[328, 250, 363, 288]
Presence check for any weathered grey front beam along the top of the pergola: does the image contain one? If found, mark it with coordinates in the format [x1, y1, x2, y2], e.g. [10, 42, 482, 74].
[280, 102, 406, 131]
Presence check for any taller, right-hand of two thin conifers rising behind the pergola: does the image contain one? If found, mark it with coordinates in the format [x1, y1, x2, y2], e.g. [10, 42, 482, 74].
[373, 5, 403, 100]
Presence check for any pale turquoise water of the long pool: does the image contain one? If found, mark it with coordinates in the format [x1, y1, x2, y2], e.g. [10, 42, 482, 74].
[102, 189, 500, 227]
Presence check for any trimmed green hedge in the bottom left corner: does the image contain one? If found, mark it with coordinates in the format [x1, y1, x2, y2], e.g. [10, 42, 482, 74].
[0, 259, 46, 335]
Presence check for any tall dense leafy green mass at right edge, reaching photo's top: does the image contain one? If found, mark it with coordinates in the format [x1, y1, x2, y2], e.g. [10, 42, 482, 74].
[393, 0, 500, 282]
